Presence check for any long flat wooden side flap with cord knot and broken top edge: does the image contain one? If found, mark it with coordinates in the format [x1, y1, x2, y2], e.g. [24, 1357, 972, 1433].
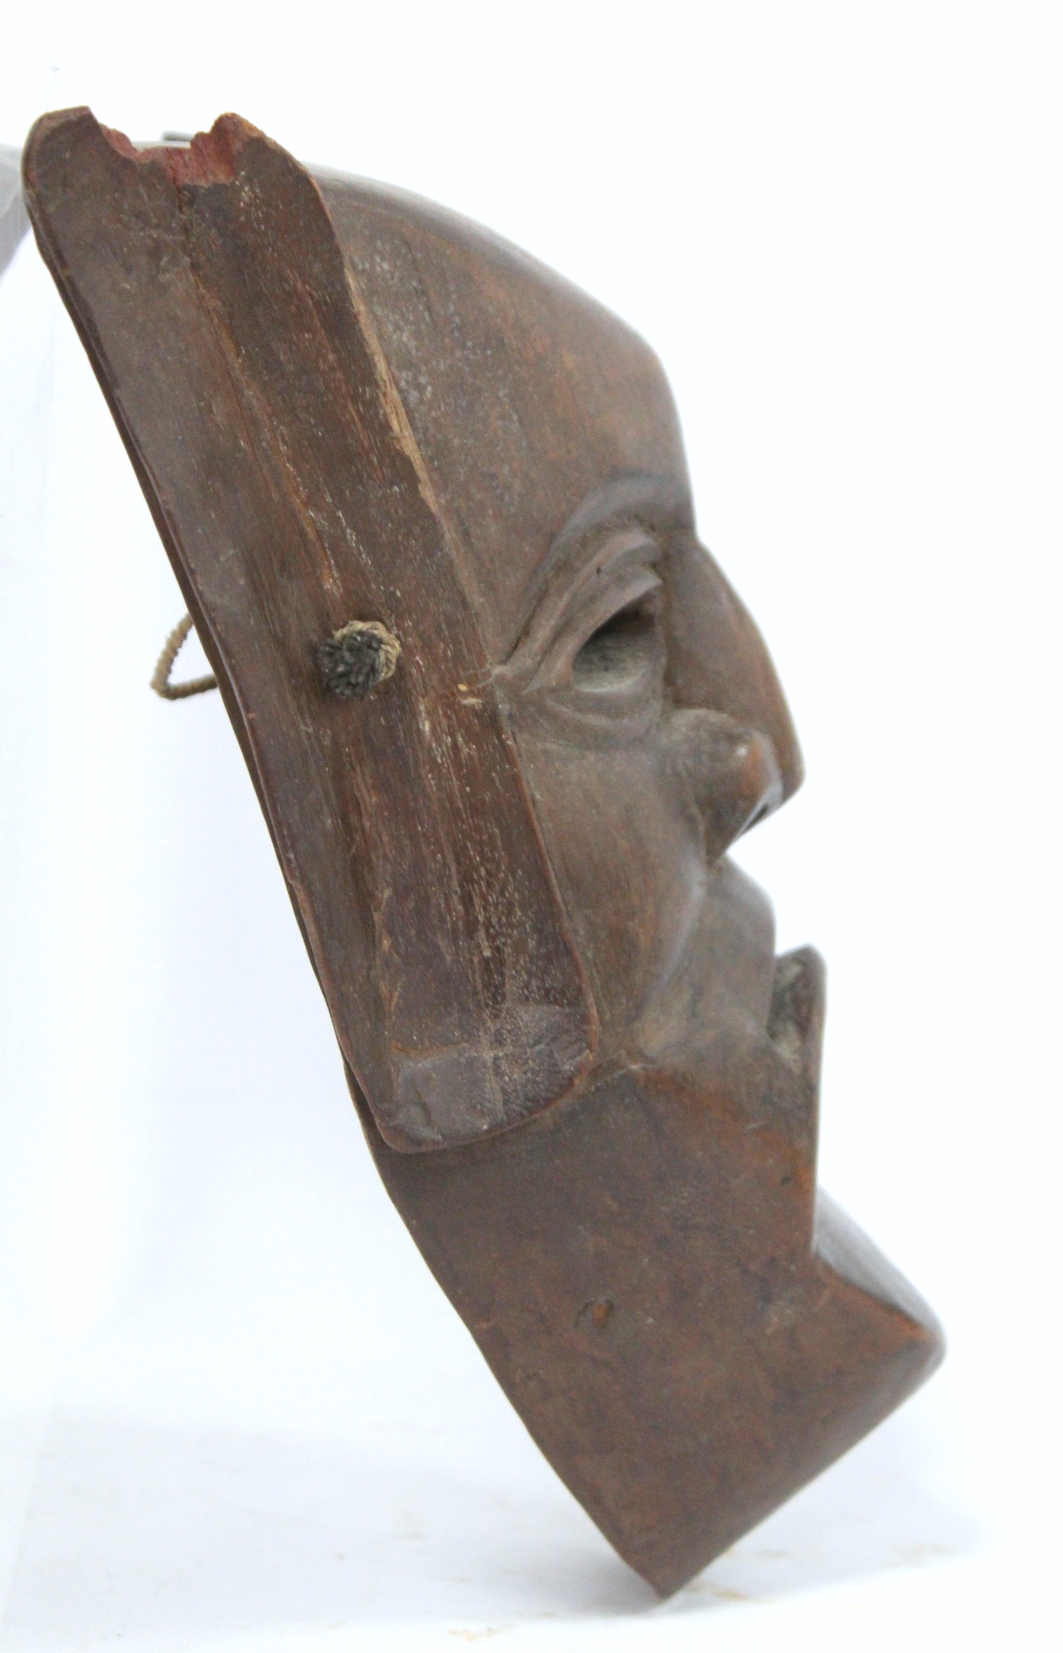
[25, 111, 597, 1149]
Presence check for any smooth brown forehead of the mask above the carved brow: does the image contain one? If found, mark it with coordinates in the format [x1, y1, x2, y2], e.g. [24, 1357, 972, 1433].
[314, 172, 686, 660]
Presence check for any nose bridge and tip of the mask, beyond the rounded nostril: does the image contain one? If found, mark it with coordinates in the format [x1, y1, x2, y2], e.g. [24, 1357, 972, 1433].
[665, 537, 805, 808]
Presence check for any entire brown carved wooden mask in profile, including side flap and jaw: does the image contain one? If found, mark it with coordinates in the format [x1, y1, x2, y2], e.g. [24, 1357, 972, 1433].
[25, 111, 941, 1592]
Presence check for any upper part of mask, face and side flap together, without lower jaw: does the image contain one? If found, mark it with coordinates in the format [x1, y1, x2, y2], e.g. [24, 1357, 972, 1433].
[26, 111, 800, 1150]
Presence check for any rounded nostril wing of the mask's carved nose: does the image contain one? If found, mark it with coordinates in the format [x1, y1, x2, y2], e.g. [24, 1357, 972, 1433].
[666, 709, 782, 860]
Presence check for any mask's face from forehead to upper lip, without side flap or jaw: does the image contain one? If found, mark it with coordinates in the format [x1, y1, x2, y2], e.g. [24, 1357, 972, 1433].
[319, 167, 800, 1050]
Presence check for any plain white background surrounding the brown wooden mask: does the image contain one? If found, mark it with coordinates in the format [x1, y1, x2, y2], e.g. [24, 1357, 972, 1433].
[0, 0, 1063, 1653]
